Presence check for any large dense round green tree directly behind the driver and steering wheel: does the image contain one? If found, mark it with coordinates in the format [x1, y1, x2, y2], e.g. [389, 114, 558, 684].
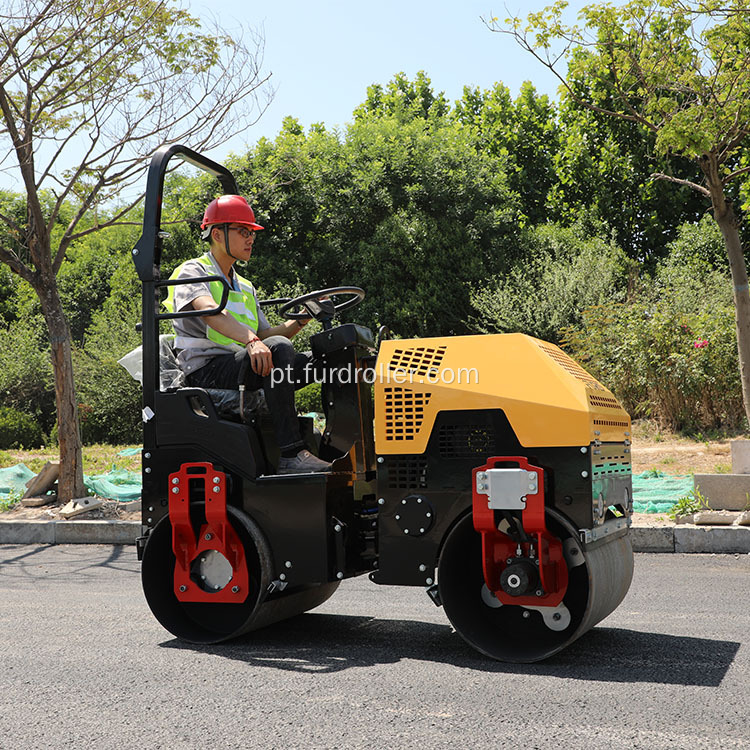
[229, 77, 520, 335]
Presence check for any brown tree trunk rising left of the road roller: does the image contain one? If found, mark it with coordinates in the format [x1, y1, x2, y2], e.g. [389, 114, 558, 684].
[37, 276, 87, 502]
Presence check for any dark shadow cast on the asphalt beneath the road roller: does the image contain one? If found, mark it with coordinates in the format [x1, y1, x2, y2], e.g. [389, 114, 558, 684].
[161, 613, 740, 687]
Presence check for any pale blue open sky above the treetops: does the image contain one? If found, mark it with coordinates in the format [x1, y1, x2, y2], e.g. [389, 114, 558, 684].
[194, 0, 586, 161]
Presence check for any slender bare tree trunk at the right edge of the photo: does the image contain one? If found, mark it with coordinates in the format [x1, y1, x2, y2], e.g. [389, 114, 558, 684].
[701, 159, 750, 432]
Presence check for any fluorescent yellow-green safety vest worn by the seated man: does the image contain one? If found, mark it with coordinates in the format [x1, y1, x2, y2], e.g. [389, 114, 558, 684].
[163, 253, 258, 349]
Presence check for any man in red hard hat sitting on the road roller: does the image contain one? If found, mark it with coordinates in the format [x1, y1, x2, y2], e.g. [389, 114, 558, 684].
[164, 195, 331, 474]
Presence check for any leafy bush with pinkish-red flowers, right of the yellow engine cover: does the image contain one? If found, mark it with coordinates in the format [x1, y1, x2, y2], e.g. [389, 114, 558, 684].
[562, 229, 745, 431]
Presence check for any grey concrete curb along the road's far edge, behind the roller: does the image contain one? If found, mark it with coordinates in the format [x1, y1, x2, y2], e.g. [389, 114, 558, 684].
[0, 520, 750, 554]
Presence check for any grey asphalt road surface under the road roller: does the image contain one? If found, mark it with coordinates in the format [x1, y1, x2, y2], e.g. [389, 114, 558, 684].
[0, 545, 750, 750]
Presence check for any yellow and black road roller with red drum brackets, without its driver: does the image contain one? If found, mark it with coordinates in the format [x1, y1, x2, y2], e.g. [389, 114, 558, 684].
[133, 145, 633, 662]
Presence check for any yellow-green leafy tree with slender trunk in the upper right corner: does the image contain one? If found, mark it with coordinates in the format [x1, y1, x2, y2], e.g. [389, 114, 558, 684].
[498, 0, 750, 428]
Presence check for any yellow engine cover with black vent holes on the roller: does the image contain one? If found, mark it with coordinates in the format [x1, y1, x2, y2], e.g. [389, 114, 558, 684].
[375, 333, 630, 454]
